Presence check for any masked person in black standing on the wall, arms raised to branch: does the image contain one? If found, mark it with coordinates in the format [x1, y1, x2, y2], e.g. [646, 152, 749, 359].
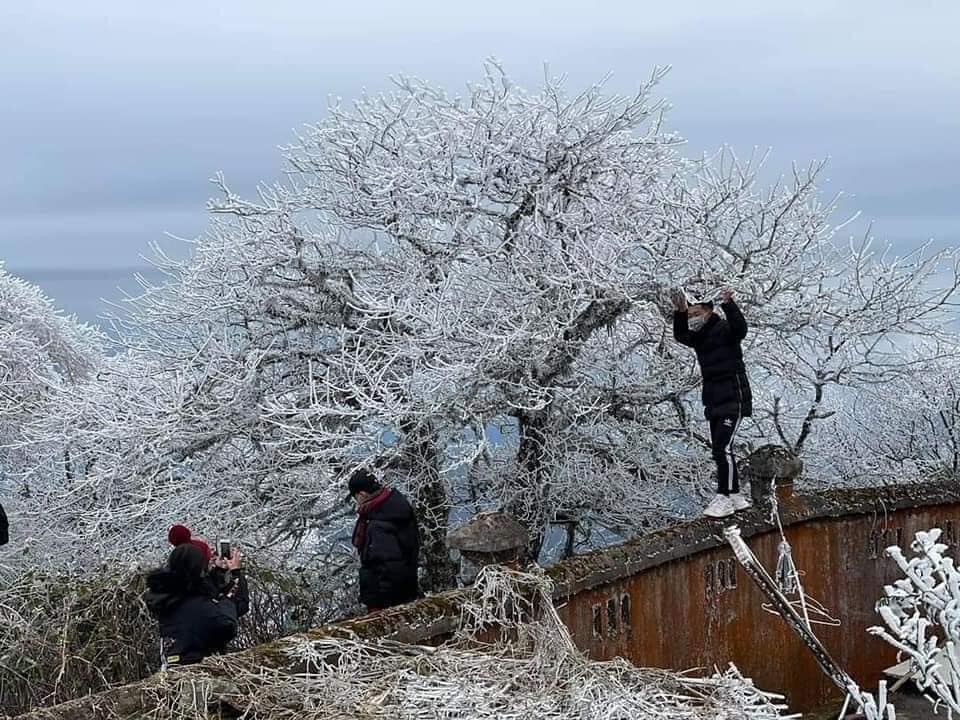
[673, 288, 753, 517]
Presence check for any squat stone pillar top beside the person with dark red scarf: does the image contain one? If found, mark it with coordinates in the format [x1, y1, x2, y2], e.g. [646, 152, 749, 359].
[447, 512, 529, 585]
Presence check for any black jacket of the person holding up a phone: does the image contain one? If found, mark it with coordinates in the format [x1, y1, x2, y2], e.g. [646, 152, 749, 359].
[144, 569, 249, 665]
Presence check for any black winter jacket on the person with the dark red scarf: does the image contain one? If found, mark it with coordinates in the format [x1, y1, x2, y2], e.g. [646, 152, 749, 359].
[359, 490, 420, 608]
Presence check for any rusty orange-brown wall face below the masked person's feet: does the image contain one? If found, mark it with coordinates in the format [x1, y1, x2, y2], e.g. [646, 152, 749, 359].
[560, 504, 960, 711]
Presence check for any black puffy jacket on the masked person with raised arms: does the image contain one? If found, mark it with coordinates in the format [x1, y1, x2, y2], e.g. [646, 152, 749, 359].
[673, 300, 753, 419]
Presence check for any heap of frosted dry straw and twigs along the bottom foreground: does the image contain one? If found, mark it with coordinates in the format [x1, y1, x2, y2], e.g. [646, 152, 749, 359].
[137, 568, 797, 720]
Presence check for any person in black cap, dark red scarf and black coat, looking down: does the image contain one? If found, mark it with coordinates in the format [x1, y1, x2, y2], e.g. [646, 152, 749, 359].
[349, 469, 420, 612]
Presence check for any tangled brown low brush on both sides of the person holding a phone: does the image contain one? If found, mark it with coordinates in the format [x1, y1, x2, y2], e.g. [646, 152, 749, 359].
[0, 548, 340, 718]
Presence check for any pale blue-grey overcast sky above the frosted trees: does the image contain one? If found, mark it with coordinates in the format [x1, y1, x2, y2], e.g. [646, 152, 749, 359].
[0, 0, 960, 270]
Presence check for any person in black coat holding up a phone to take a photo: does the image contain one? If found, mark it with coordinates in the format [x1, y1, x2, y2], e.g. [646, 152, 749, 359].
[144, 543, 249, 667]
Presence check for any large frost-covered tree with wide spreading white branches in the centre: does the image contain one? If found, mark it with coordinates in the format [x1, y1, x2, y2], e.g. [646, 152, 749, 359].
[26, 60, 956, 587]
